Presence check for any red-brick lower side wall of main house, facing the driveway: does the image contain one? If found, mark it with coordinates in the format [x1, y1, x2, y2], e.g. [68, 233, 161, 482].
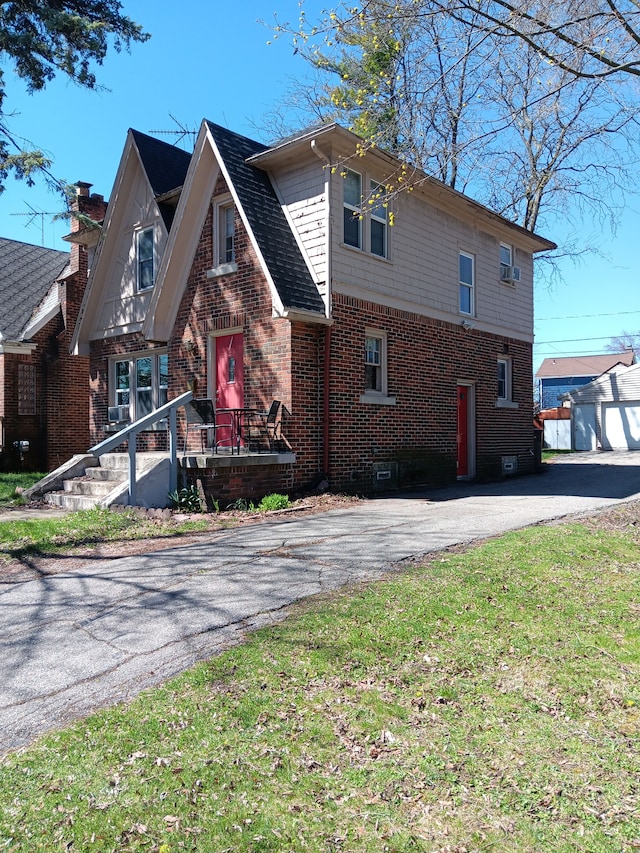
[328, 294, 533, 491]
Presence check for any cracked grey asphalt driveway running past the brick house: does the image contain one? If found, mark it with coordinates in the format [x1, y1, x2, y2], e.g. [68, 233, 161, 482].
[0, 452, 640, 752]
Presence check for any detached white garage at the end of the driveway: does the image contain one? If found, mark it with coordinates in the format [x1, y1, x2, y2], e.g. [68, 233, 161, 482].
[564, 364, 640, 450]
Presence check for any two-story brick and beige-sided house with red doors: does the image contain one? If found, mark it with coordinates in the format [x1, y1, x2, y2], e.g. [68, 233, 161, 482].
[73, 121, 554, 497]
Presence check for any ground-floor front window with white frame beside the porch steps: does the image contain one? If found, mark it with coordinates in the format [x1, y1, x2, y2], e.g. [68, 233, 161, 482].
[111, 352, 169, 421]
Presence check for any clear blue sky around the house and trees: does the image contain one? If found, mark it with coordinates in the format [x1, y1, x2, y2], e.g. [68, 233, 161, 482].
[0, 0, 640, 369]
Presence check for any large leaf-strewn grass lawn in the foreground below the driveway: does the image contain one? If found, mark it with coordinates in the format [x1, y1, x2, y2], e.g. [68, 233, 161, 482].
[0, 505, 640, 853]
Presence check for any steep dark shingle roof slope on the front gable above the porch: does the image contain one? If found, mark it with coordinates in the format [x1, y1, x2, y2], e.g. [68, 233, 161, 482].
[207, 121, 325, 314]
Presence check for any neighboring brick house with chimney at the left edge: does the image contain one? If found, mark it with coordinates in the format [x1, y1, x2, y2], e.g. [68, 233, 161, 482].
[0, 184, 105, 471]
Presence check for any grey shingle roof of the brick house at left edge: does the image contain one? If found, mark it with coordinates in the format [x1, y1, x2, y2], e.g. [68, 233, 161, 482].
[0, 237, 69, 341]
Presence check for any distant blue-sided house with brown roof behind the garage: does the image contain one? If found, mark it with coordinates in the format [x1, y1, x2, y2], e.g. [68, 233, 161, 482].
[535, 350, 635, 409]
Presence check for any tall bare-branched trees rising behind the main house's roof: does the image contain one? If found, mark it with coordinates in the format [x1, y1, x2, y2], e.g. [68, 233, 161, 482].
[274, 0, 637, 240]
